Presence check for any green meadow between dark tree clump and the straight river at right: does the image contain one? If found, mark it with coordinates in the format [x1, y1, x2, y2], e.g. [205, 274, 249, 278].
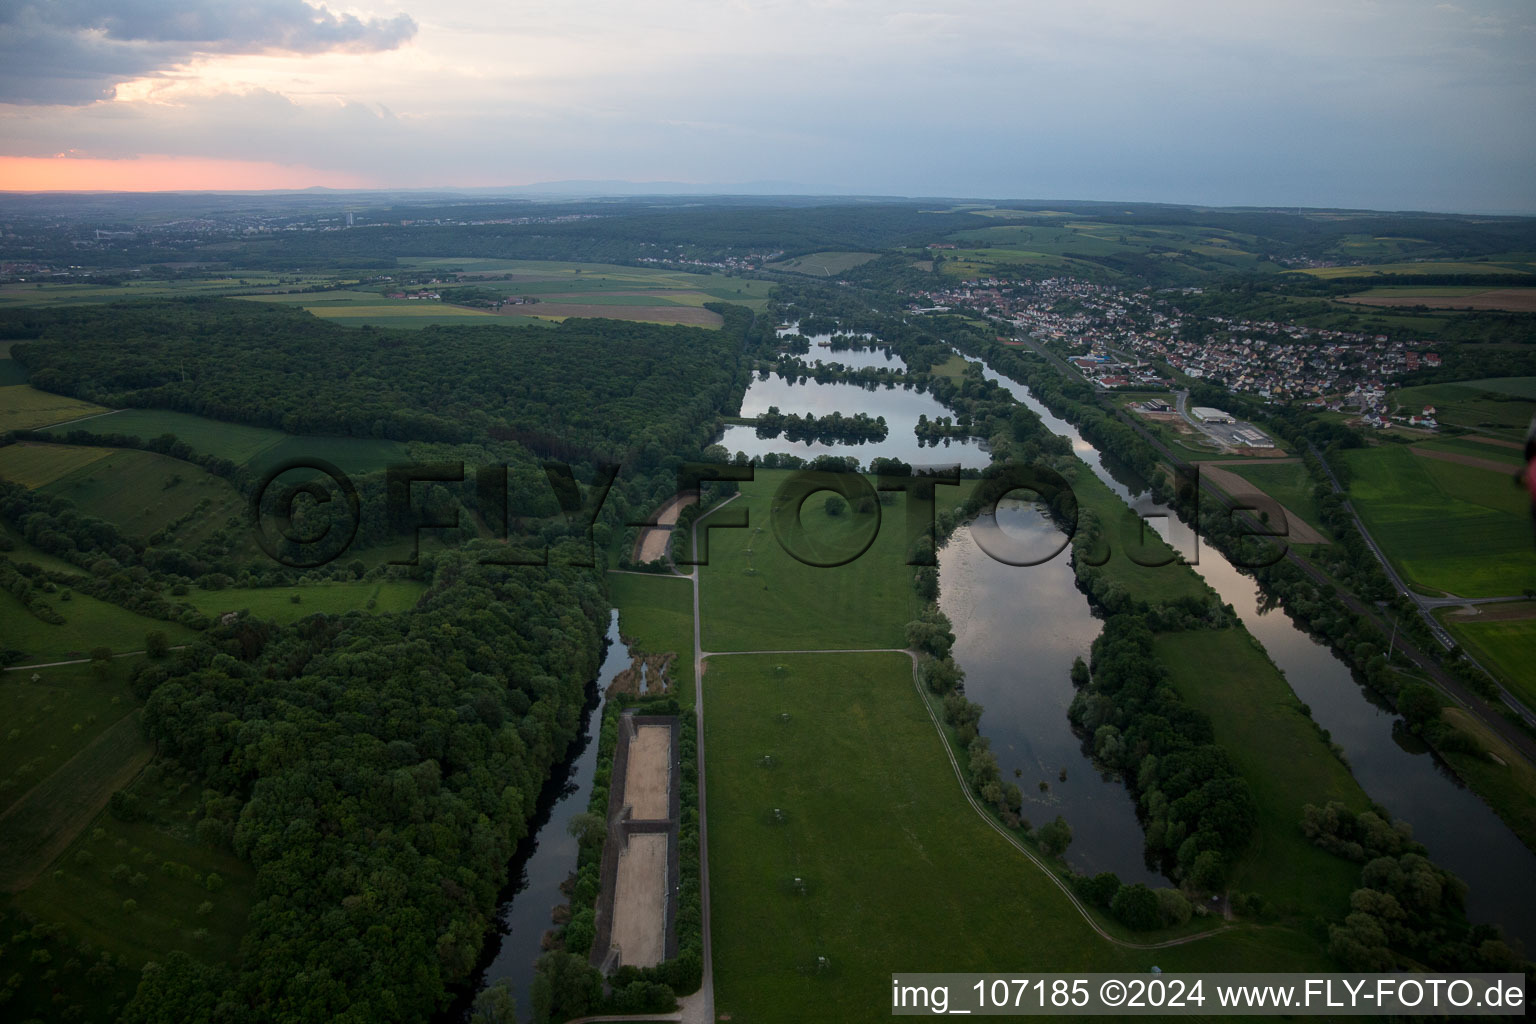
[1155, 628, 1367, 920]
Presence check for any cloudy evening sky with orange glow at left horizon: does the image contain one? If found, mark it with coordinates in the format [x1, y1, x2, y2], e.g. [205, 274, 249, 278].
[0, 0, 1536, 213]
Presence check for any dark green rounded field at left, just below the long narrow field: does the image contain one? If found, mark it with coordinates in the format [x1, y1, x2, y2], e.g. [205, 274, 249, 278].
[37, 448, 257, 556]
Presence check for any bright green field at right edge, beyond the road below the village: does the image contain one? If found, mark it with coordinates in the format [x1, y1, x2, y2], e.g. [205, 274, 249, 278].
[1344, 445, 1536, 597]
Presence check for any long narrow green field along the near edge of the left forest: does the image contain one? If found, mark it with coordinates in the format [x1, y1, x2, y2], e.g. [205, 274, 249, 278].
[42, 408, 407, 473]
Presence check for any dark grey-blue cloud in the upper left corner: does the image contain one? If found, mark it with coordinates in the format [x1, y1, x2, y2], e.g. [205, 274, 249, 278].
[0, 0, 416, 106]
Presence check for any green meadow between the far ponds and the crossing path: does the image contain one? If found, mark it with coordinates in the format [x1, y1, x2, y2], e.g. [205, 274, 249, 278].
[700, 470, 965, 651]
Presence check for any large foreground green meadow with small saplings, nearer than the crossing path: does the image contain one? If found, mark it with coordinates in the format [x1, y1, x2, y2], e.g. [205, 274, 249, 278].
[703, 654, 1321, 1024]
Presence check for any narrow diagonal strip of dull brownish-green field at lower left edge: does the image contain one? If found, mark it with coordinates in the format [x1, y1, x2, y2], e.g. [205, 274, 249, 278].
[0, 712, 154, 892]
